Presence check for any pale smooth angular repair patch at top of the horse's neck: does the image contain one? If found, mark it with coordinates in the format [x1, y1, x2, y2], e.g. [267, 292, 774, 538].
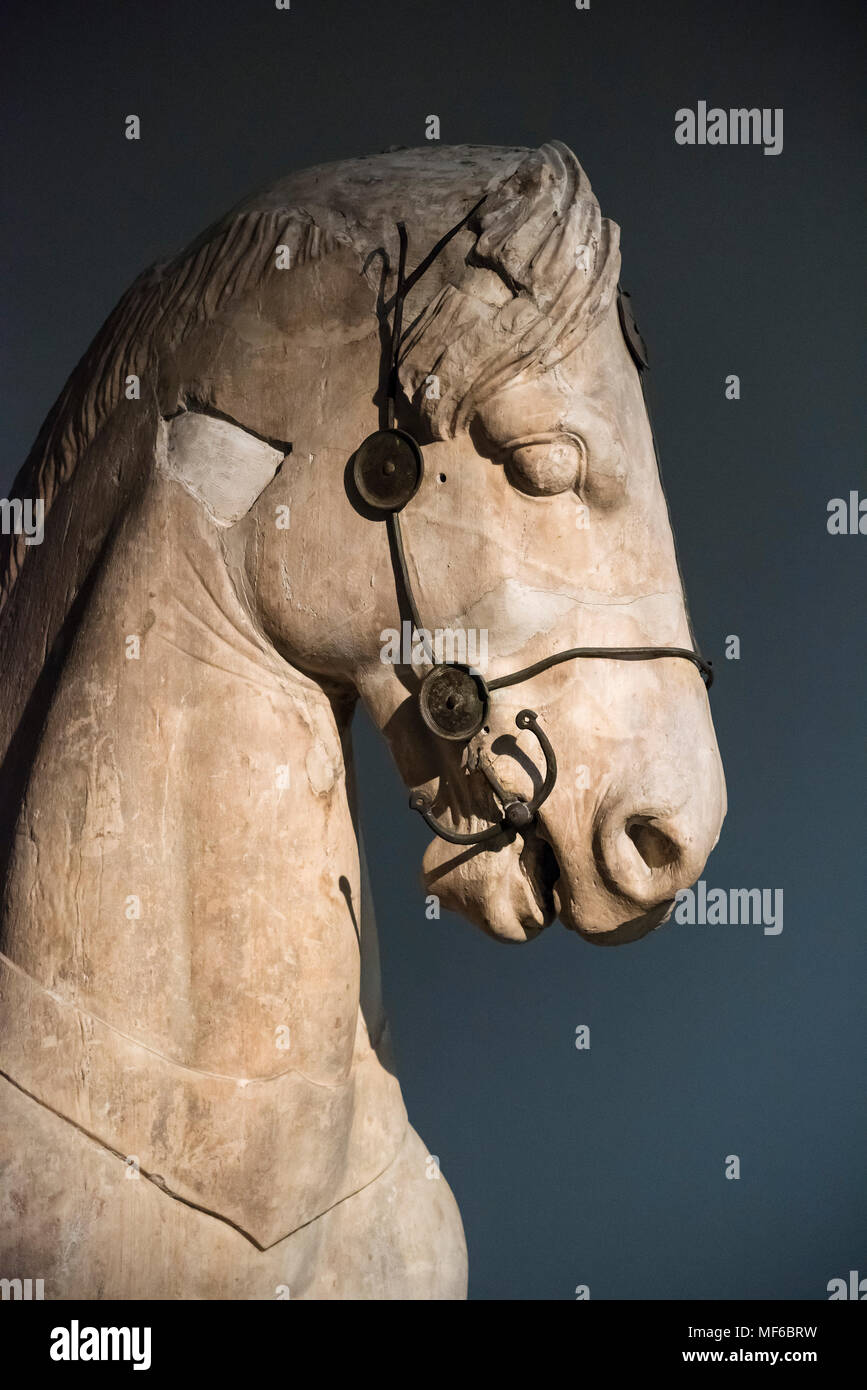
[157, 410, 292, 527]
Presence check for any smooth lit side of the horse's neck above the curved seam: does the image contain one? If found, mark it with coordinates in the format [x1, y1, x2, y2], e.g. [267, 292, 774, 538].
[4, 481, 382, 1086]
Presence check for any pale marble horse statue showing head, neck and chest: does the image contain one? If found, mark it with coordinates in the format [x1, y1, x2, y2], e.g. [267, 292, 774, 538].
[0, 143, 725, 1298]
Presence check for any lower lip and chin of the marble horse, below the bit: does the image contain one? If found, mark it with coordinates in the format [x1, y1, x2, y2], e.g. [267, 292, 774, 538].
[424, 834, 560, 942]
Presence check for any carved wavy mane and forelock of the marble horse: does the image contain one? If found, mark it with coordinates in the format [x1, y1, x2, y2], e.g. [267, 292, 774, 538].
[0, 142, 620, 610]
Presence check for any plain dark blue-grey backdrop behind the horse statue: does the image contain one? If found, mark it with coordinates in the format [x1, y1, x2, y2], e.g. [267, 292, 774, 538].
[0, 0, 867, 1298]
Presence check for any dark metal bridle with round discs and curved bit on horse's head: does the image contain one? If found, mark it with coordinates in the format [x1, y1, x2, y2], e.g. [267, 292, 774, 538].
[353, 207, 713, 845]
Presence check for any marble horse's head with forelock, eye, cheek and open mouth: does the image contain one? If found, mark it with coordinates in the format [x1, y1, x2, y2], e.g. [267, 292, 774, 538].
[211, 145, 725, 942]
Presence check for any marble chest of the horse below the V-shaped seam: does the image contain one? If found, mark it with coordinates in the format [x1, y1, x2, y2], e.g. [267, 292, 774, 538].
[0, 1079, 467, 1300]
